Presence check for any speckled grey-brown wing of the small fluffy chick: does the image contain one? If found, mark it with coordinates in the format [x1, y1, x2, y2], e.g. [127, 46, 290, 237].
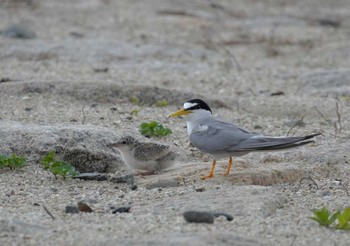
[134, 143, 170, 161]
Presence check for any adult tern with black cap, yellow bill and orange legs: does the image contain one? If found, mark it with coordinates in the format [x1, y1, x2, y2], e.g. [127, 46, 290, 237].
[170, 99, 320, 179]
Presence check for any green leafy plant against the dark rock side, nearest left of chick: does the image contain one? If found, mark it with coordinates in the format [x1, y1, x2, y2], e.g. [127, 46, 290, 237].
[40, 150, 78, 178]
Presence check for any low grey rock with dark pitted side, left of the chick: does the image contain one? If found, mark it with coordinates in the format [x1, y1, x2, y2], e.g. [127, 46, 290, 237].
[0, 121, 125, 173]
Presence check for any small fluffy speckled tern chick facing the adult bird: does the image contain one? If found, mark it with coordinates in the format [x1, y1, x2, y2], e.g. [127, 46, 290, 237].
[108, 136, 180, 174]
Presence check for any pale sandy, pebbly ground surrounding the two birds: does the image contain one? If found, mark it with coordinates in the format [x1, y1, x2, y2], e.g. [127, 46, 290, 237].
[0, 0, 350, 245]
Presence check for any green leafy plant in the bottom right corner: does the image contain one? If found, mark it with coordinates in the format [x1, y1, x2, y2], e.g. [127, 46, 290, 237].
[310, 207, 350, 230]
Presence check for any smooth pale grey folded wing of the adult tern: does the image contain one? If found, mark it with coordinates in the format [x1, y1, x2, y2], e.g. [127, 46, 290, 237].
[190, 119, 258, 154]
